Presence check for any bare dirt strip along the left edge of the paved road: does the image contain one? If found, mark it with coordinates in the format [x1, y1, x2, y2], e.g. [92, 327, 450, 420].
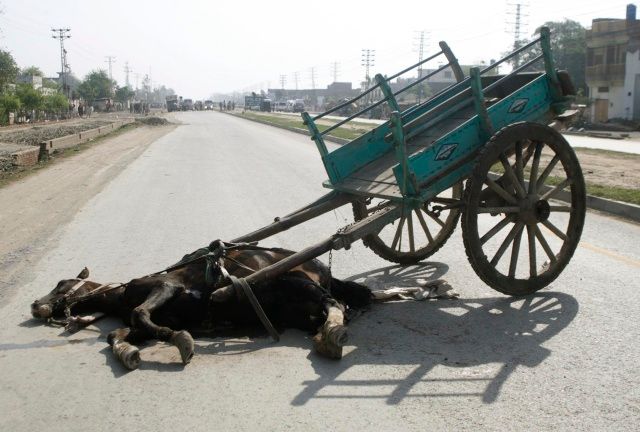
[0, 121, 176, 304]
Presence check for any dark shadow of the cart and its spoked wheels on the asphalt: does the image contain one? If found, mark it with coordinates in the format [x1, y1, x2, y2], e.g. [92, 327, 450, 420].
[291, 263, 578, 406]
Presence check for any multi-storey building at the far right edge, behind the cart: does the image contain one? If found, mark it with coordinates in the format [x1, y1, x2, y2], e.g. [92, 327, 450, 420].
[585, 4, 640, 122]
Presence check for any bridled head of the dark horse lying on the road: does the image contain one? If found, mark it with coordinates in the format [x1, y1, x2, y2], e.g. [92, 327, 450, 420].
[31, 267, 100, 320]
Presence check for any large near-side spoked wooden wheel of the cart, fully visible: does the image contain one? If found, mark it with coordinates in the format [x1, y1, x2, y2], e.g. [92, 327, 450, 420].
[462, 123, 586, 295]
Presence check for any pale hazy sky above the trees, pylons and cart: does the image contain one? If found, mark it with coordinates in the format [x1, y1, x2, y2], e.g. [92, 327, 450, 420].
[0, 0, 640, 99]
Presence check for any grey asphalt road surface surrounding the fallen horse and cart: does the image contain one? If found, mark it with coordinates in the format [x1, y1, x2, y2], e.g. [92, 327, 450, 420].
[0, 112, 640, 432]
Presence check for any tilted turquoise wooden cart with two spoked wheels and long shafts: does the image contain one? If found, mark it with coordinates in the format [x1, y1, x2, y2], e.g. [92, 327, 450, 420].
[225, 28, 585, 295]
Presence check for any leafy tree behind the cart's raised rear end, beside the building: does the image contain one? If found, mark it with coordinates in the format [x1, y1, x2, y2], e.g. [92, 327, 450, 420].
[515, 19, 587, 91]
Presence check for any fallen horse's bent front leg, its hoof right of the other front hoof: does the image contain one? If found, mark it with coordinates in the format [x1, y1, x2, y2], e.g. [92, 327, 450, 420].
[131, 282, 194, 364]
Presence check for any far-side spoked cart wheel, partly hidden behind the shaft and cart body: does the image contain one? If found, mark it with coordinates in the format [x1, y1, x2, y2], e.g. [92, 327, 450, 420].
[353, 183, 462, 264]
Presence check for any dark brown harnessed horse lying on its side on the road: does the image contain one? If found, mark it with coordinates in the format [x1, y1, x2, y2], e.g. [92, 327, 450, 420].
[31, 240, 372, 369]
